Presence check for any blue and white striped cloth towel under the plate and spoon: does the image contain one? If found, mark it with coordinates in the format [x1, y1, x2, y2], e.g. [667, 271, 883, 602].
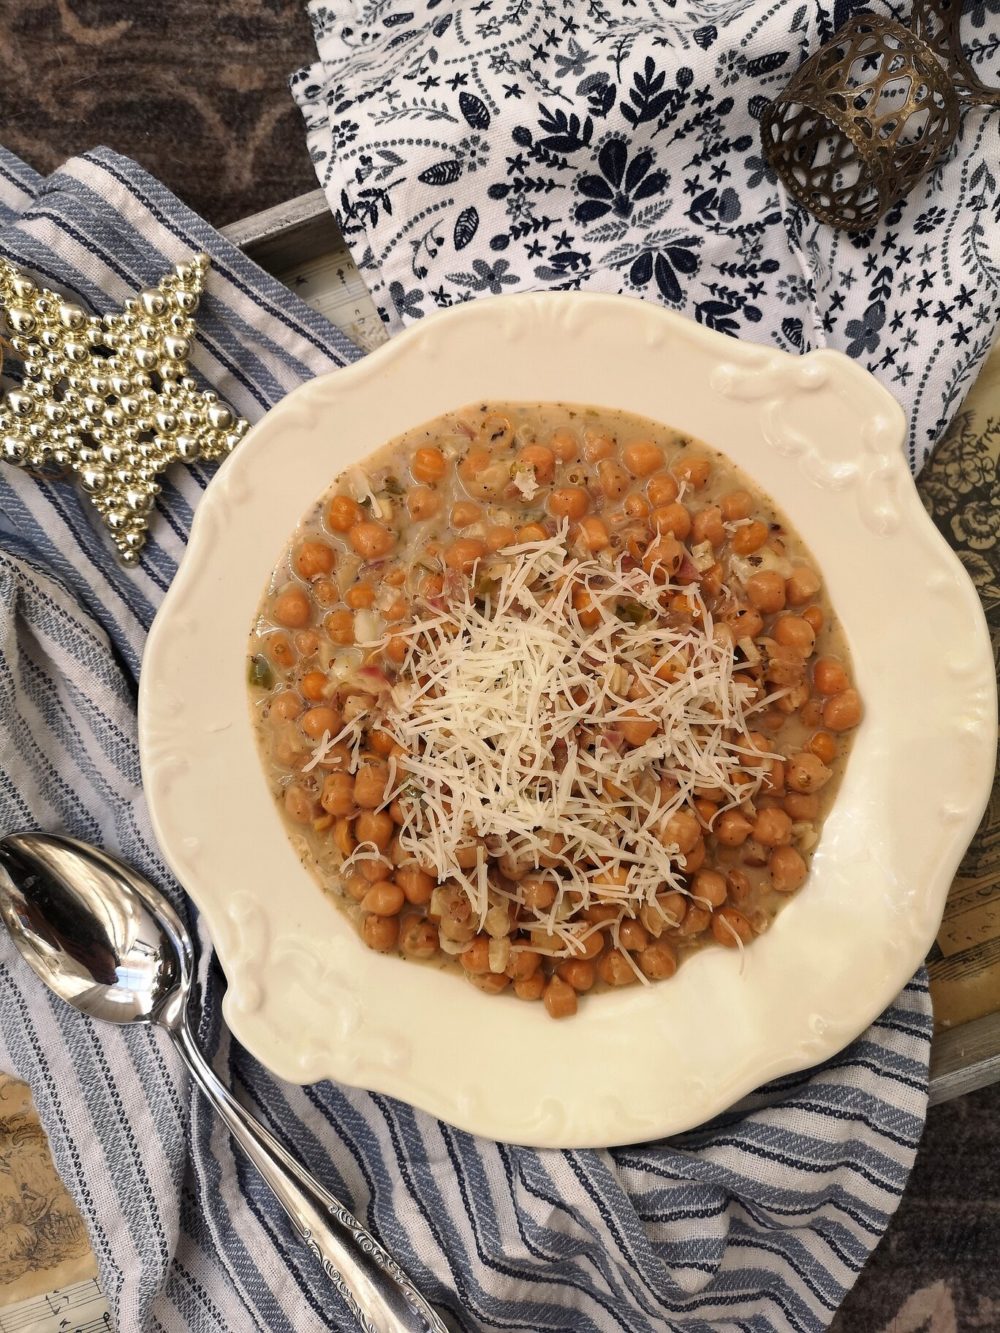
[0, 151, 931, 1333]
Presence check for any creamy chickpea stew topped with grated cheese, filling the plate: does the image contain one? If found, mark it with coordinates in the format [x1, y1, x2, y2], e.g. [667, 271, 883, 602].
[248, 403, 863, 1018]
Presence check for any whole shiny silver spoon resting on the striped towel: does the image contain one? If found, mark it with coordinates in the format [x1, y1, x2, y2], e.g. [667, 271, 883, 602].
[0, 833, 448, 1333]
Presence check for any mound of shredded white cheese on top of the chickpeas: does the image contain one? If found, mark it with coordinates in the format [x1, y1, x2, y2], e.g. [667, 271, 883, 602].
[321, 528, 764, 956]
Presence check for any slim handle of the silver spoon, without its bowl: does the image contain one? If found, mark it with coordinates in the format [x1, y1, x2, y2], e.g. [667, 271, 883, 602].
[171, 1018, 448, 1333]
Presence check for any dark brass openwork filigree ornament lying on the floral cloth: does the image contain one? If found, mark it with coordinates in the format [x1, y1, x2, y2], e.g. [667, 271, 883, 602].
[761, 0, 1000, 232]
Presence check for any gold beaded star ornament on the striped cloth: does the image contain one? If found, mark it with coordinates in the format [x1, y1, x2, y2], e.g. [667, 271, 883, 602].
[0, 255, 248, 564]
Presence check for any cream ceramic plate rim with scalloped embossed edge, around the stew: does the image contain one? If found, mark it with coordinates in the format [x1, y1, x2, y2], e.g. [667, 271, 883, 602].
[140, 293, 996, 1148]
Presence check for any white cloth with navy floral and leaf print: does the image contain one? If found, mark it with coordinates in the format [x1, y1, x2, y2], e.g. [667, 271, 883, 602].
[292, 0, 1000, 467]
